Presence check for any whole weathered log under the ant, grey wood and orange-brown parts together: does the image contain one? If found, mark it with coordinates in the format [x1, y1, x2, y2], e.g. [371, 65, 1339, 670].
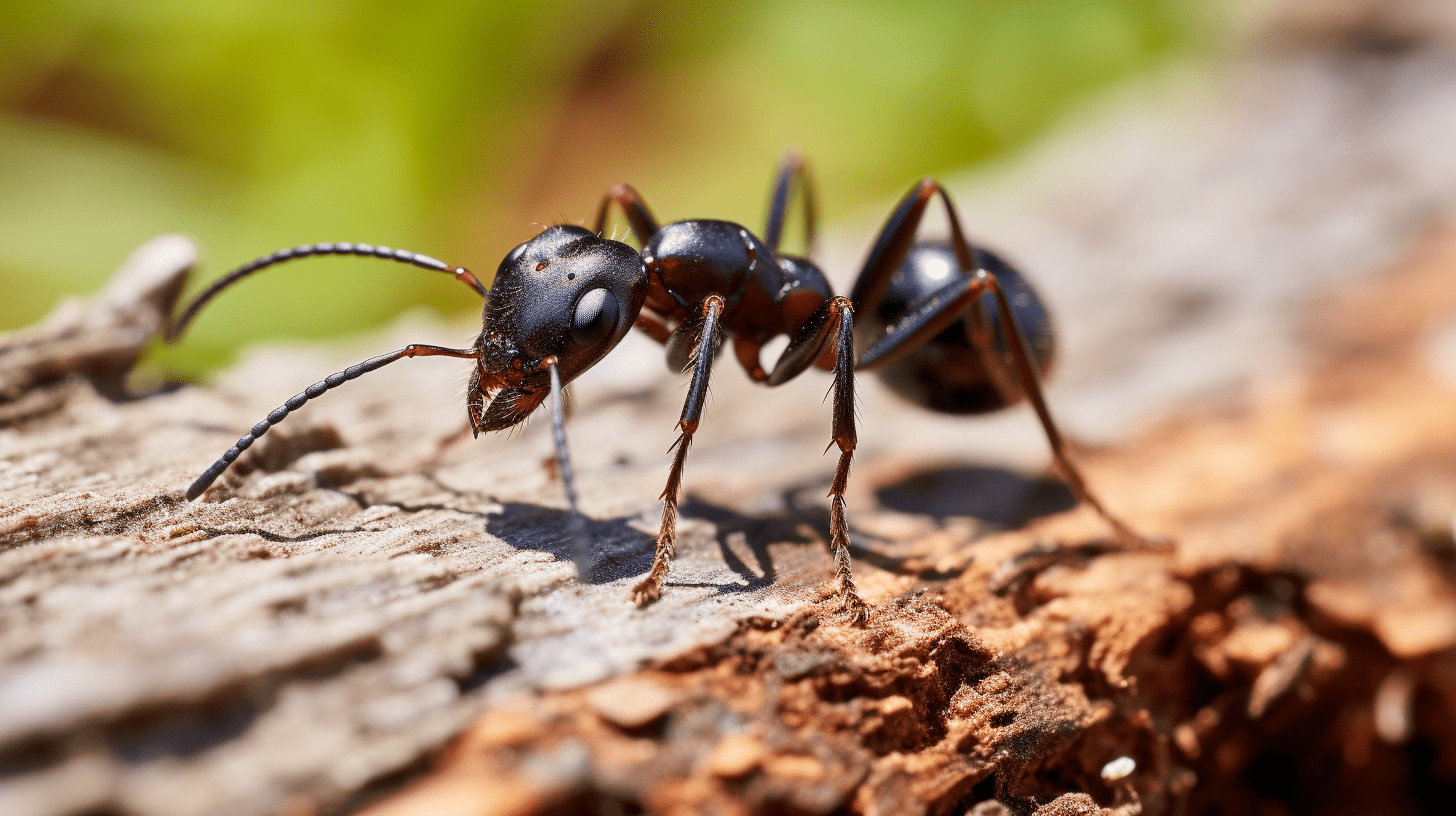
[0, 7, 1456, 816]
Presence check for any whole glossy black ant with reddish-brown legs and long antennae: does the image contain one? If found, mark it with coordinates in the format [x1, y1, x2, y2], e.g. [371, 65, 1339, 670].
[166, 154, 1146, 624]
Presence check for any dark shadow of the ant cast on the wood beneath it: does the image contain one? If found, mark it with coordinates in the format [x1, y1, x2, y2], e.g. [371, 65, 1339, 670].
[485, 465, 1077, 593]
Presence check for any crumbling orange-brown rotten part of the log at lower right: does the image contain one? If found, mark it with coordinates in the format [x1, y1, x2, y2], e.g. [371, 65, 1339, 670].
[371, 236, 1456, 816]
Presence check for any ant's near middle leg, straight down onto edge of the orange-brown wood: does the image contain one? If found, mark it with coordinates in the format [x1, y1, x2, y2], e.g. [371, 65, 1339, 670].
[767, 297, 869, 625]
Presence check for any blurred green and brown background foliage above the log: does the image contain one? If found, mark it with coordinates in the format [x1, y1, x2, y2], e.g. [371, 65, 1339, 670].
[0, 0, 1192, 373]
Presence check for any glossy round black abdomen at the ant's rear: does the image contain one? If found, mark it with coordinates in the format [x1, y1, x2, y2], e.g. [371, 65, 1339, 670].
[859, 242, 1056, 414]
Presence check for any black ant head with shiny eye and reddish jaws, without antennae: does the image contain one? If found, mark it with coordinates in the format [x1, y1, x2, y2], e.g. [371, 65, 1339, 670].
[470, 220, 646, 433]
